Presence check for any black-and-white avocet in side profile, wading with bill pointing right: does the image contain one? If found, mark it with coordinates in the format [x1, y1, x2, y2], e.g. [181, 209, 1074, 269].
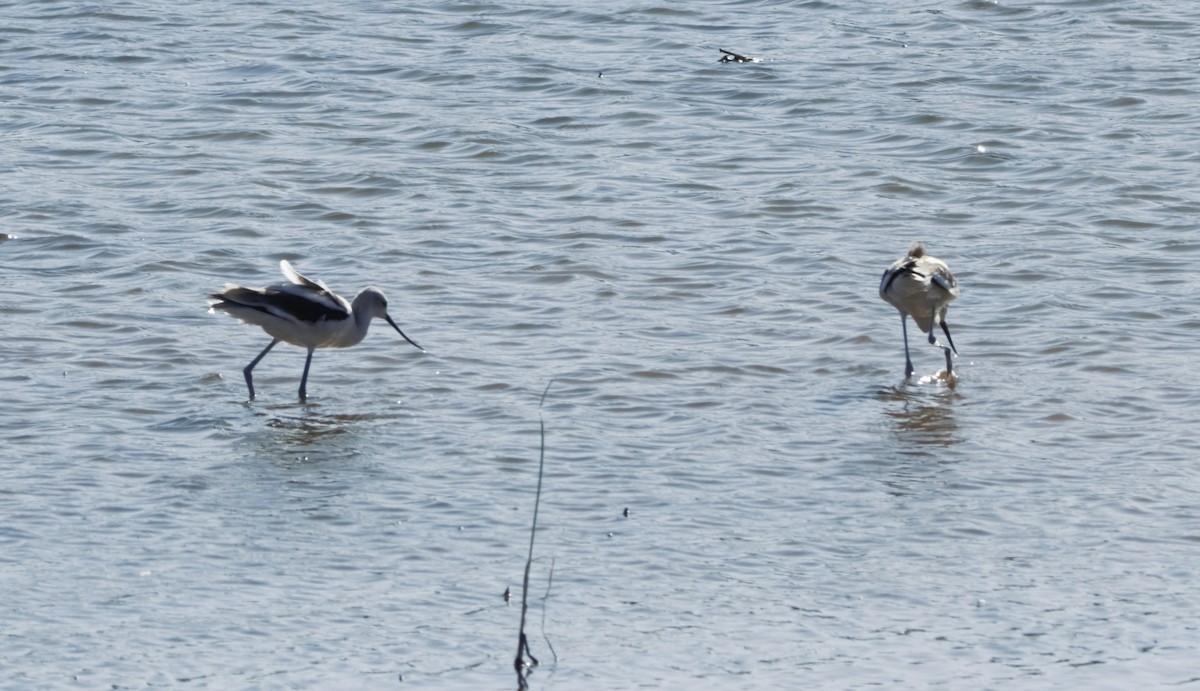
[209, 259, 425, 402]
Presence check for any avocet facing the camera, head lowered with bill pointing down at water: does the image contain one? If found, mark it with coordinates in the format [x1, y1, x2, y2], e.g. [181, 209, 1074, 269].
[880, 242, 959, 377]
